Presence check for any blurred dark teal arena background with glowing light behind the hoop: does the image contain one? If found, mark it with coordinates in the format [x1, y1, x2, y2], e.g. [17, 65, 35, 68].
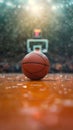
[0, 0, 73, 73]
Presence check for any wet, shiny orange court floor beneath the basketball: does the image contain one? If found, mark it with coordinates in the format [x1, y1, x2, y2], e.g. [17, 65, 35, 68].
[0, 74, 73, 130]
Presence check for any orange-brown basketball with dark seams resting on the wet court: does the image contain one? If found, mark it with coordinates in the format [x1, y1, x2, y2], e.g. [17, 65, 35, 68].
[22, 52, 50, 80]
